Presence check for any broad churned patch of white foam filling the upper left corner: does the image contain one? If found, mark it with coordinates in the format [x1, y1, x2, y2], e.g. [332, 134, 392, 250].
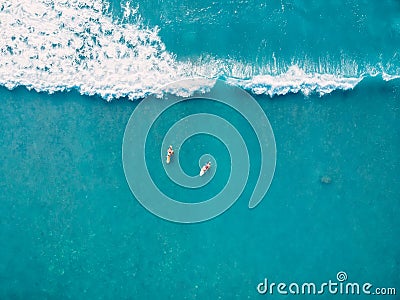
[0, 0, 192, 99]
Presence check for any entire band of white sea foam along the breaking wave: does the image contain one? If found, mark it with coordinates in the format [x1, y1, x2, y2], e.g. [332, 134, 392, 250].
[0, 0, 398, 100]
